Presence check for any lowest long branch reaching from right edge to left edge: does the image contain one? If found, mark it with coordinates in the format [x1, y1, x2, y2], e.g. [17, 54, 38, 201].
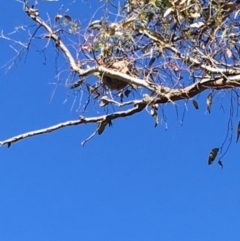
[0, 71, 240, 146]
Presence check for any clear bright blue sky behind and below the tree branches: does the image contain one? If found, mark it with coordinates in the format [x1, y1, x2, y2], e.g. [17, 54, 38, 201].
[0, 0, 240, 241]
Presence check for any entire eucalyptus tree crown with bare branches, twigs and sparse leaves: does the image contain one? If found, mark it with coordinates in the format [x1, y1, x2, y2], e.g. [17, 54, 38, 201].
[0, 0, 240, 164]
